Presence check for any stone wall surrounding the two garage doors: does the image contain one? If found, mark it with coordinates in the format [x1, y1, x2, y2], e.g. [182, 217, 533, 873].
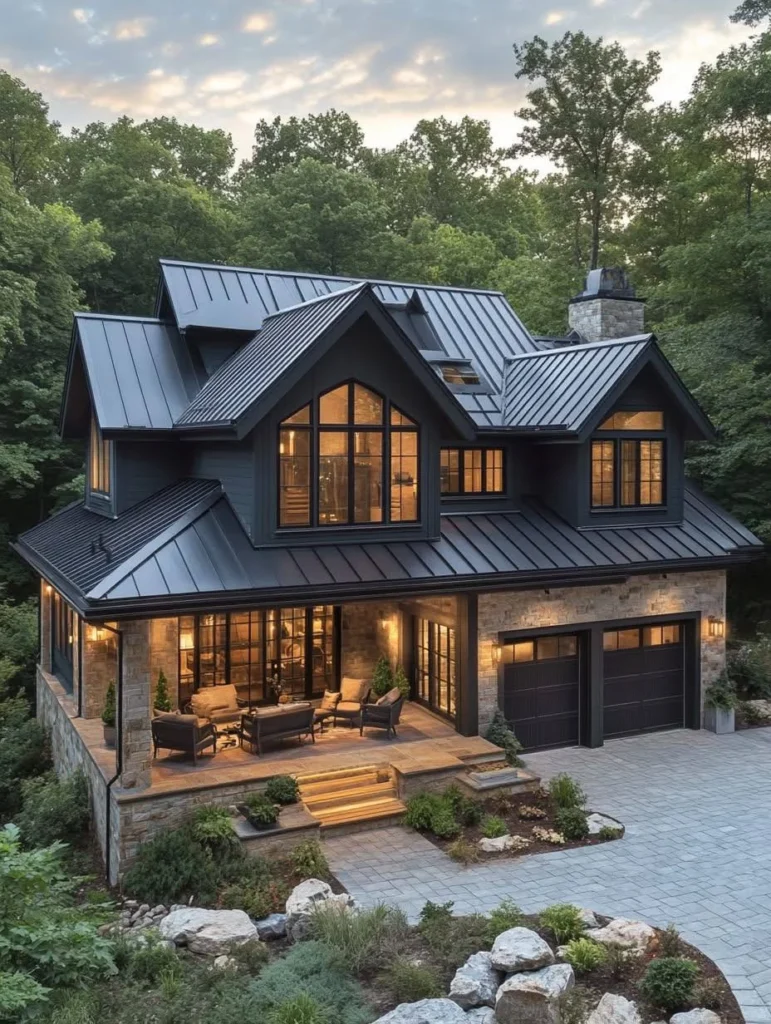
[478, 571, 726, 732]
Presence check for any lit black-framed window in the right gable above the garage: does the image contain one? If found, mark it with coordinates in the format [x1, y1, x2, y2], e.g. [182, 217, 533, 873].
[592, 411, 665, 509]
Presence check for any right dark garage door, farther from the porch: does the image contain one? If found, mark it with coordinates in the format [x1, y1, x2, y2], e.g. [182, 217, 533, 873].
[603, 624, 685, 738]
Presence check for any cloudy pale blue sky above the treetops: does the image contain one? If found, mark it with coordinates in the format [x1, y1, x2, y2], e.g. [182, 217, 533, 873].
[0, 0, 751, 156]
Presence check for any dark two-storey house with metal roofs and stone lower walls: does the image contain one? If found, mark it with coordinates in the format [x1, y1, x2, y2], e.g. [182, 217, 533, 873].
[15, 260, 761, 876]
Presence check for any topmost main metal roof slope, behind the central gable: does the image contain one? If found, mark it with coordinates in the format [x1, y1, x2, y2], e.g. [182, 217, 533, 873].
[159, 260, 538, 427]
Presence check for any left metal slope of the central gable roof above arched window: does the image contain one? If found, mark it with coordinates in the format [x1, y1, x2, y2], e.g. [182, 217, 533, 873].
[177, 284, 370, 426]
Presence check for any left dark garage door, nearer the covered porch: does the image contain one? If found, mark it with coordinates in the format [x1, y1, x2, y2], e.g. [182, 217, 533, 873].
[504, 636, 580, 751]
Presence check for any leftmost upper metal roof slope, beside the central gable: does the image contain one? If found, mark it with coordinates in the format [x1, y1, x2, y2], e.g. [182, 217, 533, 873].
[75, 313, 199, 430]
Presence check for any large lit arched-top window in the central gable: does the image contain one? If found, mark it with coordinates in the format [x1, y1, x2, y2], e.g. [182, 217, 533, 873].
[279, 382, 420, 526]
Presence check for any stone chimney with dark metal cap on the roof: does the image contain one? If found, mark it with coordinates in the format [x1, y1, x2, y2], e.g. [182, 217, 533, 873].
[567, 266, 645, 341]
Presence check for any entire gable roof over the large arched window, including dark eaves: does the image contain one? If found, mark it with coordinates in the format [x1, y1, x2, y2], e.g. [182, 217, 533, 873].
[177, 282, 474, 439]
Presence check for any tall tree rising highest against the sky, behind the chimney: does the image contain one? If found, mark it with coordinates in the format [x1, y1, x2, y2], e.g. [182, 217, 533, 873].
[510, 32, 661, 267]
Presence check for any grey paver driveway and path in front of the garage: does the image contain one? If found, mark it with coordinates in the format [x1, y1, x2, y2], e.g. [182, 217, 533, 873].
[327, 728, 771, 1024]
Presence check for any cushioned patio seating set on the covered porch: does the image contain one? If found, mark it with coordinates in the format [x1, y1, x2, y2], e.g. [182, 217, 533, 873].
[151, 677, 404, 762]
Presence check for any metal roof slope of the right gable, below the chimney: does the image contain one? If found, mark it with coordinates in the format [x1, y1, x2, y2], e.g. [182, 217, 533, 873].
[503, 335, 654, 432]
